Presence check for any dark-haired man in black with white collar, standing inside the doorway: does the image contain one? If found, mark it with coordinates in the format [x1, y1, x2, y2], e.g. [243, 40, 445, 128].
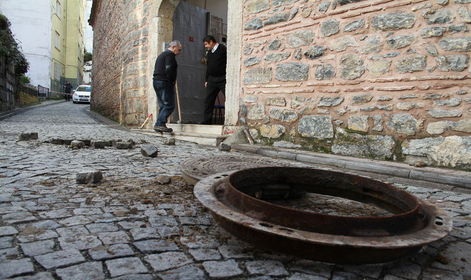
[203, 35, 227, 124]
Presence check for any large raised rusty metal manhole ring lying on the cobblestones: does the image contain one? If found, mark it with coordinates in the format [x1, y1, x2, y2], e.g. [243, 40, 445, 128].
[194, 167, 452, 264]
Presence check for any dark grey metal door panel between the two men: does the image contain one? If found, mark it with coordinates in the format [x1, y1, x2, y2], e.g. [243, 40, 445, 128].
[173, 1, 208, 123]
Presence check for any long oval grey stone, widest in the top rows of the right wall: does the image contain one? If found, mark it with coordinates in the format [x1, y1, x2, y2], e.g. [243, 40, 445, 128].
[371, 12, 415, 31]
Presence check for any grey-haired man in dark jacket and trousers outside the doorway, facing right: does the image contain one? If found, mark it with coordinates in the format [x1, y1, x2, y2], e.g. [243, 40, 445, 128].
[154, 41, 182, 132]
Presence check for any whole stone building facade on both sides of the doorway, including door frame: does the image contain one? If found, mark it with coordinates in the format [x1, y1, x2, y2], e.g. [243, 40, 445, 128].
[91, 0, 471, 170]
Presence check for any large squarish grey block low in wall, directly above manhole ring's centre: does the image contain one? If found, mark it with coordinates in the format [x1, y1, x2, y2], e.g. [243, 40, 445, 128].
[298, 115, 334, 139]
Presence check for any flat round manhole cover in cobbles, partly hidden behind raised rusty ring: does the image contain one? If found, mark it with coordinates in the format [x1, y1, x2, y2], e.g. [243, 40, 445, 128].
[180, 155, 294, 184]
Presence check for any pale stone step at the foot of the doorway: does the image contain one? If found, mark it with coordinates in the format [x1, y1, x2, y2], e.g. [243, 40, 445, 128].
[132, 129, 227, 147]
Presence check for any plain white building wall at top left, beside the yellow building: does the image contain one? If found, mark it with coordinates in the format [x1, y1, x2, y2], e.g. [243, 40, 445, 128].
[0, 0, 52, 88]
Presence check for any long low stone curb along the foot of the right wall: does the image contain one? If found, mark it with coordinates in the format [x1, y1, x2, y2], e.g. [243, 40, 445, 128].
[232, 144, 471, 190]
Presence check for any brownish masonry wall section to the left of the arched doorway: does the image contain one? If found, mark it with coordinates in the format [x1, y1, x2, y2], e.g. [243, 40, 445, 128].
[91, 0, 151, 125]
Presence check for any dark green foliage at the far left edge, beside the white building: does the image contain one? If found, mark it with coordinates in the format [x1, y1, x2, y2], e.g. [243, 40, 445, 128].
[0, 14, 29, 75]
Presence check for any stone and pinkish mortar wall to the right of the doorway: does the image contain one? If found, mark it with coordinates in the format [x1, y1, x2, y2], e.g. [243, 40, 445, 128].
[239, 0, 471, 169]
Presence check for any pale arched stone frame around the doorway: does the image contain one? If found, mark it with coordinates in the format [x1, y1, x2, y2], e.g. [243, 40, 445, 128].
[147, 0, 242, 126]
